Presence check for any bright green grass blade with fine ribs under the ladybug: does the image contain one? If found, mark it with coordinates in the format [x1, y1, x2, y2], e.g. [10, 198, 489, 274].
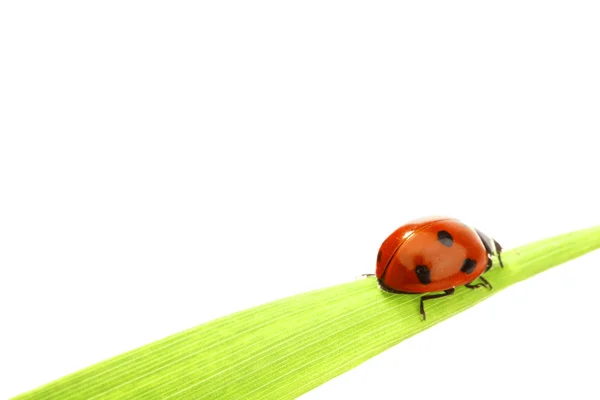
[16, 226, 600, 400]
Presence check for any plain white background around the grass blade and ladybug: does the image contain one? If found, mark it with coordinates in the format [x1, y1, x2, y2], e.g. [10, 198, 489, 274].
[0, 1, 600, 400]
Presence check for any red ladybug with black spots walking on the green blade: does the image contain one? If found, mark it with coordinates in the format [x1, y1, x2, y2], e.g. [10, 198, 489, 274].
[369, 217, 504, 320]
